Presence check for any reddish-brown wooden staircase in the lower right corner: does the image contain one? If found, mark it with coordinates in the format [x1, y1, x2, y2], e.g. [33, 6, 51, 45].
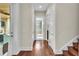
[56, 39, 79, 56]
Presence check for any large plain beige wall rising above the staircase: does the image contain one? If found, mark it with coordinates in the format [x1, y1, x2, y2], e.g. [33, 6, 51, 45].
[56, 3, 79, 50]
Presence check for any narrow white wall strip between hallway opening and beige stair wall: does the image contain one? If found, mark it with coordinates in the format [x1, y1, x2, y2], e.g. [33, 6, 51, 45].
[46, 4, 56, 52]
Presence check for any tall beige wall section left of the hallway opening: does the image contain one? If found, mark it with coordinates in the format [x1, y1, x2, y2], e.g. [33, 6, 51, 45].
[20, 4, 33, 50]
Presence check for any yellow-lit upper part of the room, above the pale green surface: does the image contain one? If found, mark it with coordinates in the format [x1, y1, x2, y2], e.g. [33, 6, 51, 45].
[0, 4, 10, 35]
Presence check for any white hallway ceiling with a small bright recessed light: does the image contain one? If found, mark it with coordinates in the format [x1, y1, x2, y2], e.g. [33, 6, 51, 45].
[33, 3, 48, 11]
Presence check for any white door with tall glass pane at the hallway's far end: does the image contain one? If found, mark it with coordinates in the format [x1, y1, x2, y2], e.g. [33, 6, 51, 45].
[36, 17, 44, 40]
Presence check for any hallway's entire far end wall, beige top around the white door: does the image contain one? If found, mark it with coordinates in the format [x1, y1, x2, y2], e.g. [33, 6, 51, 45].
[34, 11, 46, 40]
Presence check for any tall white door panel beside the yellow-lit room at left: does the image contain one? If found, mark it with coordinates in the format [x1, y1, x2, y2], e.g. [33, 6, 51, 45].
[9, 4, 21, 55]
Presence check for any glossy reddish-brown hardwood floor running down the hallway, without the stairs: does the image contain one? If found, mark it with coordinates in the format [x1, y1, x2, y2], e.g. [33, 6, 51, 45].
[17, 40, 54, 56]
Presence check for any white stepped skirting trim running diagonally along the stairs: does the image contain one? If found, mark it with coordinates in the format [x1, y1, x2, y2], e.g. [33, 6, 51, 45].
[55, 34, 79, 54]
